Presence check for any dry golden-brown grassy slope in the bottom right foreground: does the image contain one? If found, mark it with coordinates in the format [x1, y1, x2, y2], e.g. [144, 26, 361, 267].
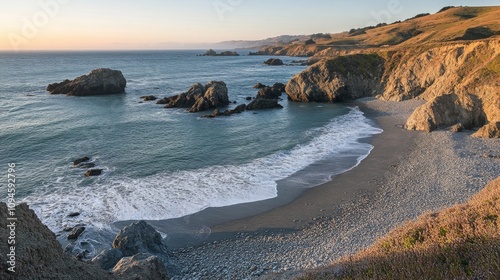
[301, 178, 500, 280]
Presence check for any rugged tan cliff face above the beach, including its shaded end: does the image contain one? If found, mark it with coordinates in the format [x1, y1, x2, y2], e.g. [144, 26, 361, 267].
[286, 37, 500, 137]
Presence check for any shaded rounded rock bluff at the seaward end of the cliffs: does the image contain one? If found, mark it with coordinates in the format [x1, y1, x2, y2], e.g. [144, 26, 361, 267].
[286, 54, 384, 102]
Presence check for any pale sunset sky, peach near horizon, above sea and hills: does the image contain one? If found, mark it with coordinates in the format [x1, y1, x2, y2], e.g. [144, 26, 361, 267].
[0, 0, 500, 51]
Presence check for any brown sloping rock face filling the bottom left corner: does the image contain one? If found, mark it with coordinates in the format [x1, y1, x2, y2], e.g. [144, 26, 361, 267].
[0, 203, 116, 280]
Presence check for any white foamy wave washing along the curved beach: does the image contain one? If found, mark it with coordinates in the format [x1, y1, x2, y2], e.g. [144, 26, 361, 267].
[23, 108, 382, 231]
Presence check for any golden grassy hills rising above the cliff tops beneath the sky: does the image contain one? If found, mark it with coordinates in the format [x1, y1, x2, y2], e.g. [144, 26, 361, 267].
[261, 6, 500, 56]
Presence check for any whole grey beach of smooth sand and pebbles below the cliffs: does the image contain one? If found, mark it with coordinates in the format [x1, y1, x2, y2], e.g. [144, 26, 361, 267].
[169, 98, 500, 279]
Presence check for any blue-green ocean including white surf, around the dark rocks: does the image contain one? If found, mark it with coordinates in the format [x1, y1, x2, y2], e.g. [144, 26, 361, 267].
[0, 51, 380, 232]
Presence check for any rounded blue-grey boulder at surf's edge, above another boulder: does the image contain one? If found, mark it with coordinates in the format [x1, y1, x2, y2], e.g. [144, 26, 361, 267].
[112, 221, 167, 257]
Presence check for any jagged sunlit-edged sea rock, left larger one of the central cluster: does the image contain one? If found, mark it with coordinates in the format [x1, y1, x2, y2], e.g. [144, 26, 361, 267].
[157, 81, 230, 113]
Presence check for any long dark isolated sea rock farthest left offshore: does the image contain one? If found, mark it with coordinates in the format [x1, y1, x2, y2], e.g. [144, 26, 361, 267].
[47, 68, 127, 96]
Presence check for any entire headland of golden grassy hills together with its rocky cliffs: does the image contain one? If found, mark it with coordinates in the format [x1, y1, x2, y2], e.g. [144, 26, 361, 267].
[279, 7, 500, 137]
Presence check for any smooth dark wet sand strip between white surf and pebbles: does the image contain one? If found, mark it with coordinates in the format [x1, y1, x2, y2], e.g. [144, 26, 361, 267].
[114, 99, 420, 249]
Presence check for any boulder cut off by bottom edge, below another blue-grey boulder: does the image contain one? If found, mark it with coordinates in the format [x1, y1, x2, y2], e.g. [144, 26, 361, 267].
[113, 253, 169, 280]
